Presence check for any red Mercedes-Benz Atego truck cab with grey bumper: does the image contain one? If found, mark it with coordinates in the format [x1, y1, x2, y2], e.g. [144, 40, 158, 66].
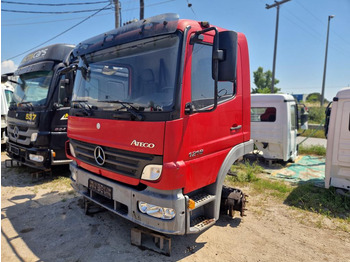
[66, 14, 253, 235]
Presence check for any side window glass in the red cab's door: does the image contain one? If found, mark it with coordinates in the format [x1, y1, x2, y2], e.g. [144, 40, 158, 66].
[191, 43, 235, 110]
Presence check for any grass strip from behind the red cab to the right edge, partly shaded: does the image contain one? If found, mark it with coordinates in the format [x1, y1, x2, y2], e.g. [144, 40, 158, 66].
[226, 161, 350, 232]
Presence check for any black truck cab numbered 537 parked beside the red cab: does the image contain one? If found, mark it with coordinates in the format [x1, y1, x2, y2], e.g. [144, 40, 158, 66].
[6, 44, 74, 170]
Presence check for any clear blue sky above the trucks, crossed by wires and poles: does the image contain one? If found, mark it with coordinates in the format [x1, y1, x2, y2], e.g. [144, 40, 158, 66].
[1, 0, 350, 100]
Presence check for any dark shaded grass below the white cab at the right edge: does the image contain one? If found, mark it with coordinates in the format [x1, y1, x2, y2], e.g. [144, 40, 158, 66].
[285, 183, 350, 221]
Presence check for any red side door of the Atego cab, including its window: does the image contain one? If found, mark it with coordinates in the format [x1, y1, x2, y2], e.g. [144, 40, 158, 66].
[183, 39, 243, 191]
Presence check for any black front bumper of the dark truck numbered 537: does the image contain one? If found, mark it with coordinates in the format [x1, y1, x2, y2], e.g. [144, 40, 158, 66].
[6, 141, 72, 170]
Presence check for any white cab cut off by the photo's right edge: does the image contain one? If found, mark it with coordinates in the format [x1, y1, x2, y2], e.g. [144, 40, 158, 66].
[325, 88, 350, 190]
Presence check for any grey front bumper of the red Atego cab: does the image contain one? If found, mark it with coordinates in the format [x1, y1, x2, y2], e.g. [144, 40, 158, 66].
[70, 162, 187, 235]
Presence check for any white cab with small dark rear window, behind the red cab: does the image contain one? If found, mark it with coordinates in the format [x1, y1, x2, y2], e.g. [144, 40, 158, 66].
[251, 94, 298, 162]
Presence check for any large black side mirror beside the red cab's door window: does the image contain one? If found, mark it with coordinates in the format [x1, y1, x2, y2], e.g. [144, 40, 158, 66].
[213, 31, 238, 81]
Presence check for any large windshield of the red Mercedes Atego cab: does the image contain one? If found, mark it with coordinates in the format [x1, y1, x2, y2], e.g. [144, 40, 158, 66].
[72, 34, 180, 112]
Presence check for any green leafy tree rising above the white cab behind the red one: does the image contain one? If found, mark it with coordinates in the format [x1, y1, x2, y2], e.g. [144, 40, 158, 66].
[252, 66, 281, 94]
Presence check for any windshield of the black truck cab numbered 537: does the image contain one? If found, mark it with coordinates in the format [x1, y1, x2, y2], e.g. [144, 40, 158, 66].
[13, 71, 53, 106]
